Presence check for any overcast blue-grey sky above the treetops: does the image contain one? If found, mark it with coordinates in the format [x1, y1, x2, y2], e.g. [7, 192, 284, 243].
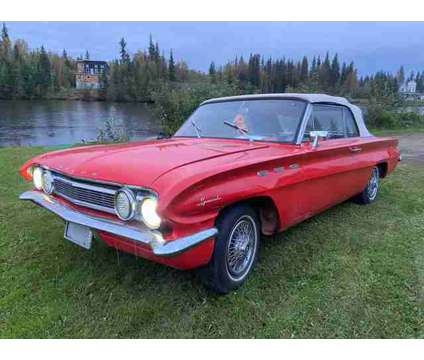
[6, 22, 424, 75]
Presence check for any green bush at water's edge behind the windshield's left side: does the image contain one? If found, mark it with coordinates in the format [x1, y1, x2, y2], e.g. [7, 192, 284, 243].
[152, 82, 240, 134]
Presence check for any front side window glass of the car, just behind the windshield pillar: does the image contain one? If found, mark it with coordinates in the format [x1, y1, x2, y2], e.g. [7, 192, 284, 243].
[306, 105, 345, 139]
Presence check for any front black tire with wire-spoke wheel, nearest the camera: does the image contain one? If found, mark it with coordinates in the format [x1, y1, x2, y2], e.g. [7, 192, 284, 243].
[200, 204, 260, 294]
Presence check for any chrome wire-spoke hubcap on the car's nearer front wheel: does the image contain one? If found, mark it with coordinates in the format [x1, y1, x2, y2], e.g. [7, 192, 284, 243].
[227, 215, 257, 280]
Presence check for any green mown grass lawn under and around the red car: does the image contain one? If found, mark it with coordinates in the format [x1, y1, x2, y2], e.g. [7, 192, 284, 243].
[0, 148, 424, 338]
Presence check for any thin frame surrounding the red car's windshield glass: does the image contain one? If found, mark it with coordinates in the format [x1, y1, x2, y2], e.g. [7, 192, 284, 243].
[172, 95, 310, 144]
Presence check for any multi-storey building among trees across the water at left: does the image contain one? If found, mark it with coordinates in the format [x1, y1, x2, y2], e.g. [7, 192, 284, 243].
[75, 60, 108, 89]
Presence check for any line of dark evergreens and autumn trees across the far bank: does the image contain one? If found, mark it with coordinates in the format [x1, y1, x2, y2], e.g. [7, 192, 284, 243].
[0, 24, 424, 101]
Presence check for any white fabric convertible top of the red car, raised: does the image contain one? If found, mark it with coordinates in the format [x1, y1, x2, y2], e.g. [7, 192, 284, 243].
[200, 93, 372, 137]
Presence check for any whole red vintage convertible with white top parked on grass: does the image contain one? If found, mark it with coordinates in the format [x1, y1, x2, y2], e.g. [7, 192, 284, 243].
[20, 94, 400, 293]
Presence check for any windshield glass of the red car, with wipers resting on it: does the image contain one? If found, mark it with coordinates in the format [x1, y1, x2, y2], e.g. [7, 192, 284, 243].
[174, 99, 306, 142]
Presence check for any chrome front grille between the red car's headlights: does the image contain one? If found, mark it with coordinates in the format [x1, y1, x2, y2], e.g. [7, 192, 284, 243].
[53, 174, 117, 213]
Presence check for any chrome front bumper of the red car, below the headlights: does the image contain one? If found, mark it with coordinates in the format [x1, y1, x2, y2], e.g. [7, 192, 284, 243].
[19, 191, 218, 256]
